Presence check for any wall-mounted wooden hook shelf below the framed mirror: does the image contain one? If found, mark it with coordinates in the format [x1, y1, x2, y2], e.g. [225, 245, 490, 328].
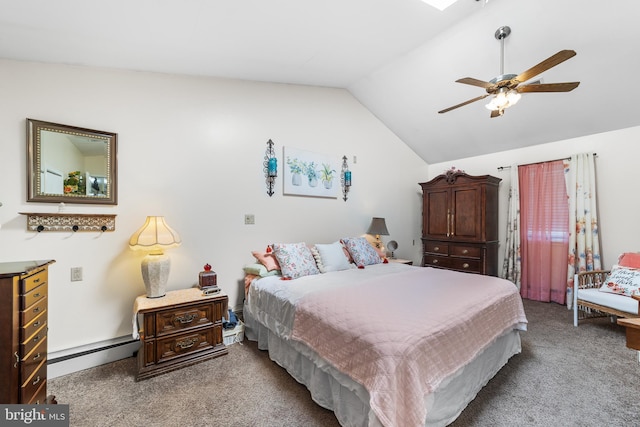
[19, 212, 116, 233]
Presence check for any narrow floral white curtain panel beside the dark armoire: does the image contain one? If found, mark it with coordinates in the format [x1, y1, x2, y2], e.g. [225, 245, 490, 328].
[502, 165, 522, 289]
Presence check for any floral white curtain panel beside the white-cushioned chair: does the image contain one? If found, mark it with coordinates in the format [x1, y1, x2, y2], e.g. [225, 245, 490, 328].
[564, 153, 602, 309]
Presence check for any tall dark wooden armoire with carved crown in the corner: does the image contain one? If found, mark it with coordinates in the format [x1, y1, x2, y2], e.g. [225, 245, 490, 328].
[420, 169, 501, 276]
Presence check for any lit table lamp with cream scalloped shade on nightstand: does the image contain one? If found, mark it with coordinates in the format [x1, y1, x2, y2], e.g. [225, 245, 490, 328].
[129, 216, 182, 298]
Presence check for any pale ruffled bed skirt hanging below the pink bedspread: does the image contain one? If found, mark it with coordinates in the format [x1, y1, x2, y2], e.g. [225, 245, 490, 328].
[243, 310, 521, 427]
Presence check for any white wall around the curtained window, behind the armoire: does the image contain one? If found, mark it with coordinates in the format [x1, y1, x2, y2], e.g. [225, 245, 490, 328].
[429, 127, 640, 271]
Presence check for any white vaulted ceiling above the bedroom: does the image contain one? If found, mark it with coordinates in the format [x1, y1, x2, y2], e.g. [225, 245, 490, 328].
[0, 0, 640, 163]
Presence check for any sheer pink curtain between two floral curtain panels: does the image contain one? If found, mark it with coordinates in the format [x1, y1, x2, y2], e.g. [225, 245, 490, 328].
[518, 160, 569, 304]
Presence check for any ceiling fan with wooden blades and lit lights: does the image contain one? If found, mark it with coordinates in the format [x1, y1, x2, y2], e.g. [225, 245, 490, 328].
[438, 26, 580, 118]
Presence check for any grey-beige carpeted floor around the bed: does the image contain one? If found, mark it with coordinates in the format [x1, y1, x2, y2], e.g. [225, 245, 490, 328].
[48, 300, 640, 427]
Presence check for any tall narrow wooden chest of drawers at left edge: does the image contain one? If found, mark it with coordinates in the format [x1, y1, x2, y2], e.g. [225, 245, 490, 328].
[0, 260, 55, 404]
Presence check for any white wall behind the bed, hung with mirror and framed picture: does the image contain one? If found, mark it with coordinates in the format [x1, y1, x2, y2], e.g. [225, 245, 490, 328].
[0, 60, 427, 352]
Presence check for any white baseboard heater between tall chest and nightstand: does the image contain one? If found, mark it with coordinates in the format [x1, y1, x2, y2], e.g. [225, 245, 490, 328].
[47, 335, 140, 378]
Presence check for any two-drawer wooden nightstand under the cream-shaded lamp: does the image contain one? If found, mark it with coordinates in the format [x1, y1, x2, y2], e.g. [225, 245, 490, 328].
[133, 288, 229, 381]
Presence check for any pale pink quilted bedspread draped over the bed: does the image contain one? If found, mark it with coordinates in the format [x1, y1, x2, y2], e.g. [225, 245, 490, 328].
[292, 268, 527, 427]
